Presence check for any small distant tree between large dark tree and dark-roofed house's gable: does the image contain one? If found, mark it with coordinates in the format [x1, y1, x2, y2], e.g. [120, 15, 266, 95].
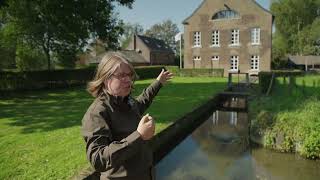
[120, 23, 144, 49]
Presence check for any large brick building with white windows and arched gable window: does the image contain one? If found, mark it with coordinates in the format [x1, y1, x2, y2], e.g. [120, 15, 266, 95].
[183, 0, 273, 76]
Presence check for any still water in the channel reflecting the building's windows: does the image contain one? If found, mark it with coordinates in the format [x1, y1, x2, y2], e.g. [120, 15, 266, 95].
[156, 102, 320, 180]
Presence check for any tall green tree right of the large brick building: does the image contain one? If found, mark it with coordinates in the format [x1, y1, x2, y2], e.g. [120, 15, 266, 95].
[271, 0, 320, 55]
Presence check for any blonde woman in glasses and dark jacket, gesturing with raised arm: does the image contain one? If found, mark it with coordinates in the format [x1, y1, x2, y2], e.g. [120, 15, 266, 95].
[82, 52, 172, 180]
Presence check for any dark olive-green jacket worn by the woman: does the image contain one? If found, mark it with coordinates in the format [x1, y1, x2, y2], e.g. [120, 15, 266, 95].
[82, 81, 161, 180]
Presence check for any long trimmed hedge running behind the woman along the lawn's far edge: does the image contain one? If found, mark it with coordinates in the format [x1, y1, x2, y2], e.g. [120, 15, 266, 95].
[0, 66, 223, 91]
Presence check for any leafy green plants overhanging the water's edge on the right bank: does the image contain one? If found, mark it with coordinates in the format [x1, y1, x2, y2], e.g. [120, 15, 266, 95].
[258, 97, 320, 159]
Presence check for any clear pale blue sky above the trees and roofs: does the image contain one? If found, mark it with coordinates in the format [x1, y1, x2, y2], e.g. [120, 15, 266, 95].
[116, 0, 270, 31]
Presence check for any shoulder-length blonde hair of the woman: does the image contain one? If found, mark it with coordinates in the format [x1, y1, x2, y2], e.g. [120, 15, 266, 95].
[87, 52, 137, 97]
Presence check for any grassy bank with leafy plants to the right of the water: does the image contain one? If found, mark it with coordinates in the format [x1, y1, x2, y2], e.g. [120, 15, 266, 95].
[249, 75, 320, 159]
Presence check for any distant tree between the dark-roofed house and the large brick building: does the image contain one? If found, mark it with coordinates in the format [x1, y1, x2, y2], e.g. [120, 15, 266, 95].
[145, 20, 179, 50]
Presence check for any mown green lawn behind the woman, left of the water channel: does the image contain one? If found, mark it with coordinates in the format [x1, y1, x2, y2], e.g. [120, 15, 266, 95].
[0, 77, 227, 179]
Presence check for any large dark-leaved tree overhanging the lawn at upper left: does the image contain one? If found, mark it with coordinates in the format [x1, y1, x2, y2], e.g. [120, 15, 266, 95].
[1, 0, 134, 70]
